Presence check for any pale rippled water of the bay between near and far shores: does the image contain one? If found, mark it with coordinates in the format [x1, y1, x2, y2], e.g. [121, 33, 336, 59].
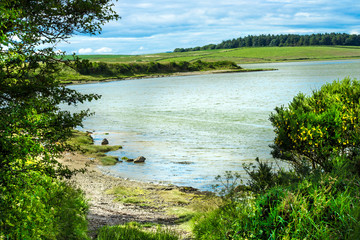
[66, 60, 360, 189]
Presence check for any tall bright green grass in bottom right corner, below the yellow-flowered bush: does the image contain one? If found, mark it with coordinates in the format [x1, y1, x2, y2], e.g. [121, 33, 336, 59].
[194, 174, 360, 239]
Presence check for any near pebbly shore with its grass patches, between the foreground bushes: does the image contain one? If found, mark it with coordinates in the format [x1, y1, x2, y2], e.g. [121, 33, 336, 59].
[59, 153, 220, 239]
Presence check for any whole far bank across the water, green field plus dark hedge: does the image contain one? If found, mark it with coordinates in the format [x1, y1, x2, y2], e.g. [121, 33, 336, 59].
[58, 46, 360, 83]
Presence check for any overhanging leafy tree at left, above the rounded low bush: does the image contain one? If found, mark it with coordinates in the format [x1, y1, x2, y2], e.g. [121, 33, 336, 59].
[0, 0, 118, 180]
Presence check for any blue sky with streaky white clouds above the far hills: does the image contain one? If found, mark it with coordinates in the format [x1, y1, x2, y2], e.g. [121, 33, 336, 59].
[57, 0, 360, 55]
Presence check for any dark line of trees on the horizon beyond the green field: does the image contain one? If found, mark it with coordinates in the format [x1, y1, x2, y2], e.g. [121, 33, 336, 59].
[174, 33, 360, 52]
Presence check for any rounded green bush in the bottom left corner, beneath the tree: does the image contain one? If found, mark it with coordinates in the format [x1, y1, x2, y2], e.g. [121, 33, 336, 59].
[0, 170, 88, 240]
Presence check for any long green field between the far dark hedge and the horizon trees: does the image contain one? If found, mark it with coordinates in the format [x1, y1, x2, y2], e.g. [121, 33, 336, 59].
[72, 46, 360, 64]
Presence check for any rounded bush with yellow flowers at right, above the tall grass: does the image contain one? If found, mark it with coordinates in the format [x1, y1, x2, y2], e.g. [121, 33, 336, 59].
[270, 78, 360, 172]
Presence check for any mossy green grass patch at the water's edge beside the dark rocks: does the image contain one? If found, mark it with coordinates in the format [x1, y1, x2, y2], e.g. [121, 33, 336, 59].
[67, 130, 121, 166]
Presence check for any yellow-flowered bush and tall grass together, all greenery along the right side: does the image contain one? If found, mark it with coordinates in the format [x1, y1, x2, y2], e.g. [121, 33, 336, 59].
[194, 79, 360, 239]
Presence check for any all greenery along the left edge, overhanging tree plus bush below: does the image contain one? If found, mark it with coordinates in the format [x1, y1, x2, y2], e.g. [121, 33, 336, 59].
[0, 0, 118, 236]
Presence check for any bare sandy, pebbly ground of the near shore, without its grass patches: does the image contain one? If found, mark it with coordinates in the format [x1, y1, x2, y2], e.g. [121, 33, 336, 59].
[59, 153, 205, 239]
